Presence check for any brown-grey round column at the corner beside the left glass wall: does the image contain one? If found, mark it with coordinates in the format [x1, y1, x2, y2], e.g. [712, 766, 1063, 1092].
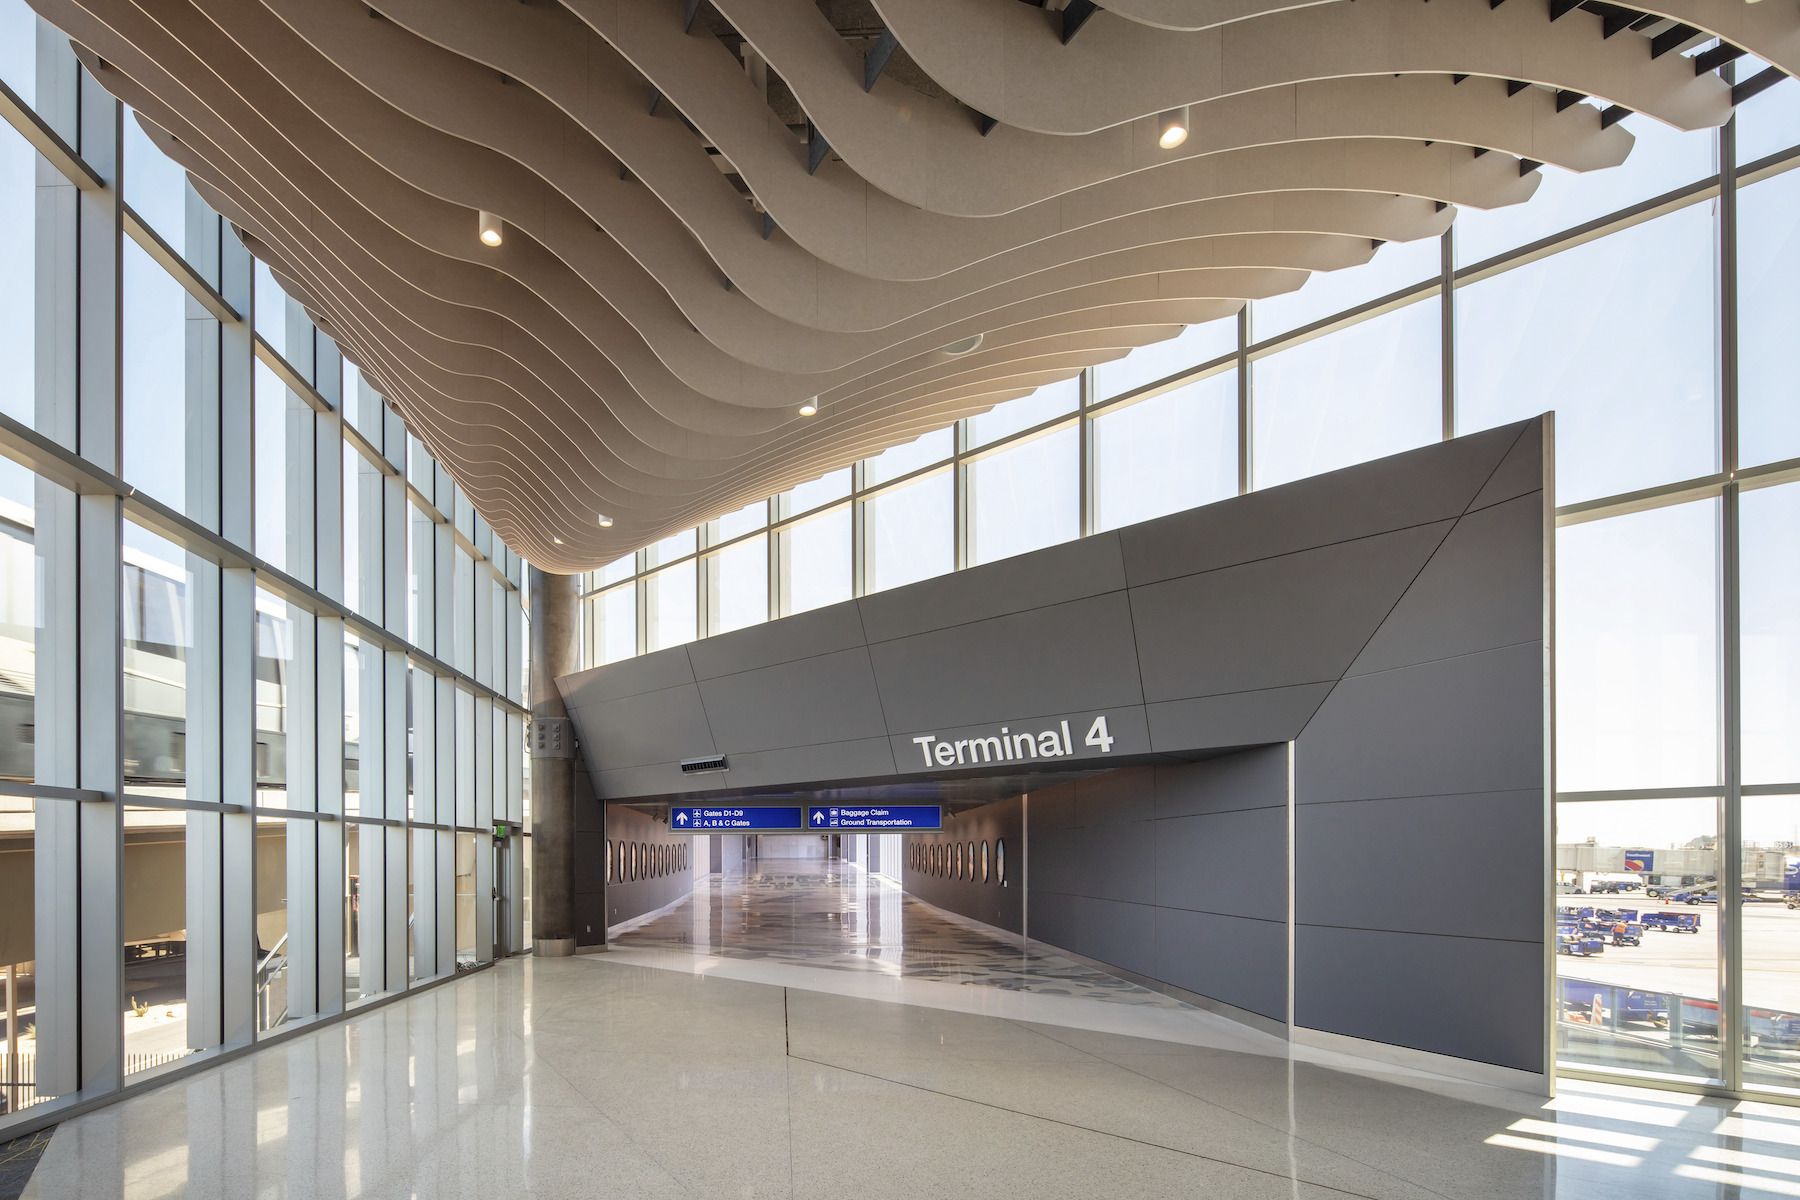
[529, 567, 580, 955]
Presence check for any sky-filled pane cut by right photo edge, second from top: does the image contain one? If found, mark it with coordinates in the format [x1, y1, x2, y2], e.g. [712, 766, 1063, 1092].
[1735, 169, 1800, 466]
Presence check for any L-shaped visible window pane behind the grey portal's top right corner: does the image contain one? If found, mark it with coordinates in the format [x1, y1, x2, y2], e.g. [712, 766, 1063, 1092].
[1456, 203, 1719, 504]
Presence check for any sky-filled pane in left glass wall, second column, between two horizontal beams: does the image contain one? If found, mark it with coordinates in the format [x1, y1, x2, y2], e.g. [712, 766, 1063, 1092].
[119, 239, 194, 513]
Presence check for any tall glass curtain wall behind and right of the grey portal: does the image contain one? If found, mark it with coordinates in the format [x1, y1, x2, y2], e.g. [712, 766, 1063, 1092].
[583, 77, 1800, 1094]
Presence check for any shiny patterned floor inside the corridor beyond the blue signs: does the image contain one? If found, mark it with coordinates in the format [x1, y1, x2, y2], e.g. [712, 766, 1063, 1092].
[612, 858, 1190, 1011]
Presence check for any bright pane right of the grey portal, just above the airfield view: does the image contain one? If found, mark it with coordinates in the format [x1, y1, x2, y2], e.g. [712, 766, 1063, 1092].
[1557, 500, 1719, 792]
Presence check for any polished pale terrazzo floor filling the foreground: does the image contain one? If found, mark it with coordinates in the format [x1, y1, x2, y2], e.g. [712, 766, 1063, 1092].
[10, 859, 1800, 1200]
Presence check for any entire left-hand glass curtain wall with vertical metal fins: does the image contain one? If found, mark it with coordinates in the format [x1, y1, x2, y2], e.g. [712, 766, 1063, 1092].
[0, 0, 525, 1141]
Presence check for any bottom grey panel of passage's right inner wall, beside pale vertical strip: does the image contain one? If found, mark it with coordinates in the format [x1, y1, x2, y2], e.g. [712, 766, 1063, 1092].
[1147, 909, 1287, 1020]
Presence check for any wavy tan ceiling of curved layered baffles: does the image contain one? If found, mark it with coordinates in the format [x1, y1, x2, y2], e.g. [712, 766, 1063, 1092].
[31, 0, 1800, 570]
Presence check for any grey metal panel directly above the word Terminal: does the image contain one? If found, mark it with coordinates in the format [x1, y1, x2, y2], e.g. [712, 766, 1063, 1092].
[869, 592, 1143, 734]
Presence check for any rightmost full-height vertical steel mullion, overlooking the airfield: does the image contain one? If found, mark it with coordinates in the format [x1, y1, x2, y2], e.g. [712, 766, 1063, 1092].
[1717, 91, 1748, 1092]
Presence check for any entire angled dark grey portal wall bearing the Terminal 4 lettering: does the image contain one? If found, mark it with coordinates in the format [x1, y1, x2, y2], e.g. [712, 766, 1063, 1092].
[558, 417, 1550, 1072]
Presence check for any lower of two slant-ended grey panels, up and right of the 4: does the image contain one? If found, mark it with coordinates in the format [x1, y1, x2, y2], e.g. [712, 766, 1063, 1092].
[1130, 522, 1451, 703]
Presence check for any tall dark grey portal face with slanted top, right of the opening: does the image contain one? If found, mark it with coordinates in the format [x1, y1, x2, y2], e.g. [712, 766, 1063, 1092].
[1294, 423, 1550, 1070]
